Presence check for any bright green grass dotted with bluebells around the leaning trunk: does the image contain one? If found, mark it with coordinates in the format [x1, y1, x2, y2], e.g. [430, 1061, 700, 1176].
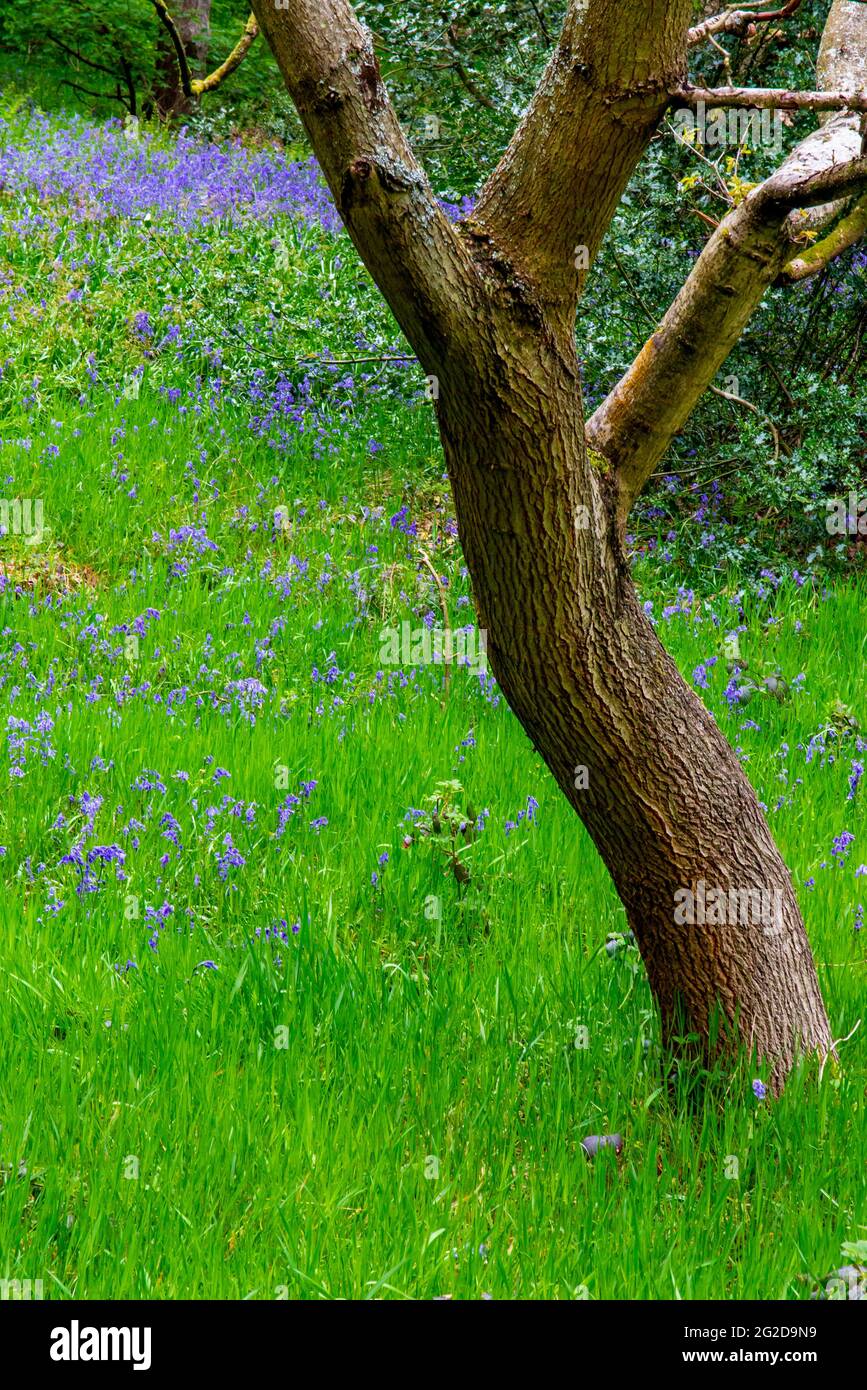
[0, 100, 867, 1298]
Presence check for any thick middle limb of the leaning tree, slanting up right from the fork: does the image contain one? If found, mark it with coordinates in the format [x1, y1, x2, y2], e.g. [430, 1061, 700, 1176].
[470, 0, 692, 339]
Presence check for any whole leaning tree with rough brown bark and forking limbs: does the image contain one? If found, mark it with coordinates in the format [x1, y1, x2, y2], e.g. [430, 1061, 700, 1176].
[245, 0, 867, 1088]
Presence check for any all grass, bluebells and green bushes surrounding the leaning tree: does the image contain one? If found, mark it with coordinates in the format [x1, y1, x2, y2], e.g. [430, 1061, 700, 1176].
[0, 0, 867, 1298]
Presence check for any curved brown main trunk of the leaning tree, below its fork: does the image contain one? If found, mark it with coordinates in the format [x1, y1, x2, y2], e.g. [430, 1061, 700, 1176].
[439, 314, 831, 1084]
